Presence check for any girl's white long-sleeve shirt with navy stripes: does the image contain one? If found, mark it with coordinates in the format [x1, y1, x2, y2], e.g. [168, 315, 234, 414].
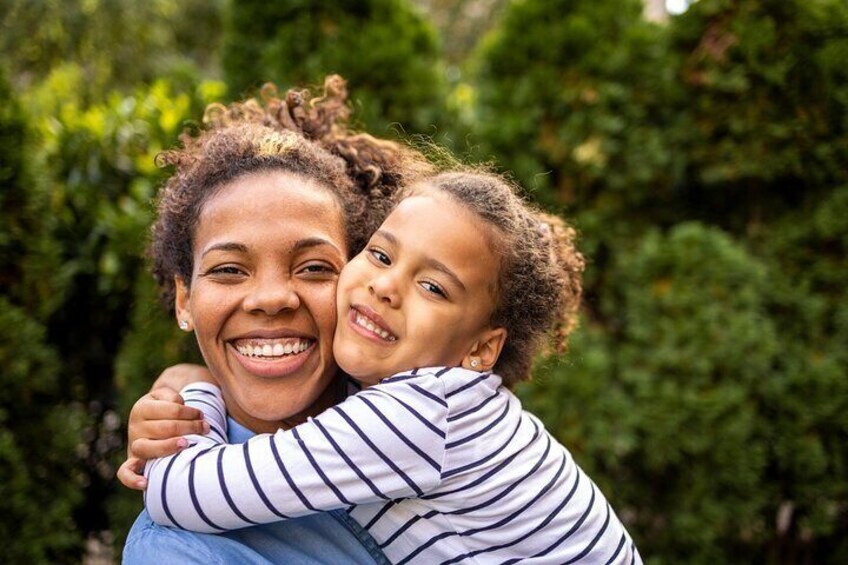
[145, 368, 641, 564]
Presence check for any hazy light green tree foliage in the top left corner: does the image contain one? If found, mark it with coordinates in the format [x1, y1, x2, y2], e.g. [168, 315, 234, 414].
[0, 0, 223, 94]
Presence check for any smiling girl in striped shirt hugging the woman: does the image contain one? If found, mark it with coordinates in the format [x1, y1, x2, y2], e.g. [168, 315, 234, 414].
[145, 173, 641, 563]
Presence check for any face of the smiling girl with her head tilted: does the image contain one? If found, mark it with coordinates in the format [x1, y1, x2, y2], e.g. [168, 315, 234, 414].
[333, 192, 505, 384]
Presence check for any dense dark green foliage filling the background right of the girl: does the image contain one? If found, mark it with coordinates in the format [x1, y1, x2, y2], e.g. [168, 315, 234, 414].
[480, 0, 848, 563]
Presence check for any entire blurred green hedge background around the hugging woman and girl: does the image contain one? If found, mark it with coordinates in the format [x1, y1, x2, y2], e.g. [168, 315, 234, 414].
[0, 0, 848, 564]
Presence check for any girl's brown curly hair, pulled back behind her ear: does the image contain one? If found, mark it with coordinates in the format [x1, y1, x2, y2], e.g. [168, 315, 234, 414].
[404, 171, 585, 387]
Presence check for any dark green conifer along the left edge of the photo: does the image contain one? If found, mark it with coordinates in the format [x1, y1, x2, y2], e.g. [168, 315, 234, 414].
[0, 65, 85, 563]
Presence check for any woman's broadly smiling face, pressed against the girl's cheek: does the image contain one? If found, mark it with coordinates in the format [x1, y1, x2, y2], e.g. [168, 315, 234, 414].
[176, 171, 347, 432]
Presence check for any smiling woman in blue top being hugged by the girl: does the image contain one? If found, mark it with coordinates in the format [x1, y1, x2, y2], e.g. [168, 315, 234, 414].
[124, 77, 428, 563]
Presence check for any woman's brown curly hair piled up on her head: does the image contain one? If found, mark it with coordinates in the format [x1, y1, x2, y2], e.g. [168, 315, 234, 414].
[148, 75, 432, 308]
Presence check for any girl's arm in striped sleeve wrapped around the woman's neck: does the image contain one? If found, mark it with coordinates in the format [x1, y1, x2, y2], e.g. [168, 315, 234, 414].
[145, 376, 447, 532]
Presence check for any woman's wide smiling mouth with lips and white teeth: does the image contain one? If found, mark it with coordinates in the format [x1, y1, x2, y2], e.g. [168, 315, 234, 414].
[227, 338, 316, 378]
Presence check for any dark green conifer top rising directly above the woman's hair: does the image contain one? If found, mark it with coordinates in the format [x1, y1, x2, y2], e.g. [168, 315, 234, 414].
[222, 0, 444, 135]
